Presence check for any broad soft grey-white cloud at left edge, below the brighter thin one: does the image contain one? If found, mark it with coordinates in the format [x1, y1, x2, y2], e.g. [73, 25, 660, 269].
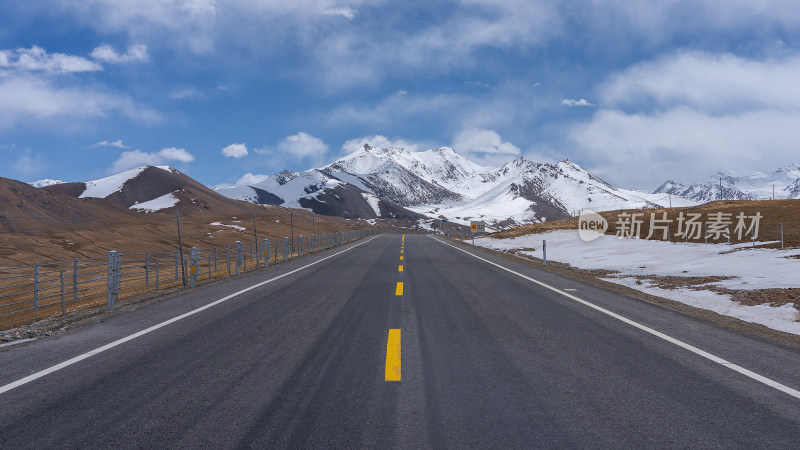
[0, 75, 162, 128]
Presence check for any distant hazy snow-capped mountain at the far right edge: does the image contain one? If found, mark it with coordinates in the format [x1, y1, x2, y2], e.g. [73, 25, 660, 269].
[655, 164, 800, 202]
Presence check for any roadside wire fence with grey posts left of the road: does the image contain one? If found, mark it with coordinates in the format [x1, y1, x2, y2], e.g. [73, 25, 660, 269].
[0, 228, 383, 329]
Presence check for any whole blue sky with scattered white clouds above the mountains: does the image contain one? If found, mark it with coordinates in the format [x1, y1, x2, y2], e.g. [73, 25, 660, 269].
[0, 0, 800, 190]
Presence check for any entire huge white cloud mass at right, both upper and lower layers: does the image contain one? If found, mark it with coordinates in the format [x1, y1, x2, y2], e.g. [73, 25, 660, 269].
[569, 52, 800, 189]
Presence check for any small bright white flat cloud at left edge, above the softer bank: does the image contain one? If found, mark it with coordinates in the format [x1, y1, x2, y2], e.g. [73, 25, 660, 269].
[0, 45, 103, 74]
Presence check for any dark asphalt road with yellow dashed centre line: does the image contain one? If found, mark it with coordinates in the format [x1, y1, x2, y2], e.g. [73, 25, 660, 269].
[0, 235, 800, 448]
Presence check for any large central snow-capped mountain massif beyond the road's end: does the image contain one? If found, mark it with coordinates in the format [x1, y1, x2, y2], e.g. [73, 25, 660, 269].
[217, 145, 694, 227]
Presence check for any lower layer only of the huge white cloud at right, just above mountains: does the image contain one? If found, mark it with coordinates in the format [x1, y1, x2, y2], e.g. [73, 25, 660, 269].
[570, 108, 800, 189]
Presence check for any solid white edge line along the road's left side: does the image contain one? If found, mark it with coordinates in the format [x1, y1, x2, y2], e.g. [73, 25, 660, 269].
[0, 236, 378, 394]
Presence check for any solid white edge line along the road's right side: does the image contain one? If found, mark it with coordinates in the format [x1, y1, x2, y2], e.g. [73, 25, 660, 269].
[431, 237, 800, 399]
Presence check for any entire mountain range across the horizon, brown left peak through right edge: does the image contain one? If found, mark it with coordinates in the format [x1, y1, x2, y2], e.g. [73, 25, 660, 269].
[29, 148, 800, 229]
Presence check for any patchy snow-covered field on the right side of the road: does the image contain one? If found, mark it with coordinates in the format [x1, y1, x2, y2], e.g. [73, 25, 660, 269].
[468, 230, 800, 334]
